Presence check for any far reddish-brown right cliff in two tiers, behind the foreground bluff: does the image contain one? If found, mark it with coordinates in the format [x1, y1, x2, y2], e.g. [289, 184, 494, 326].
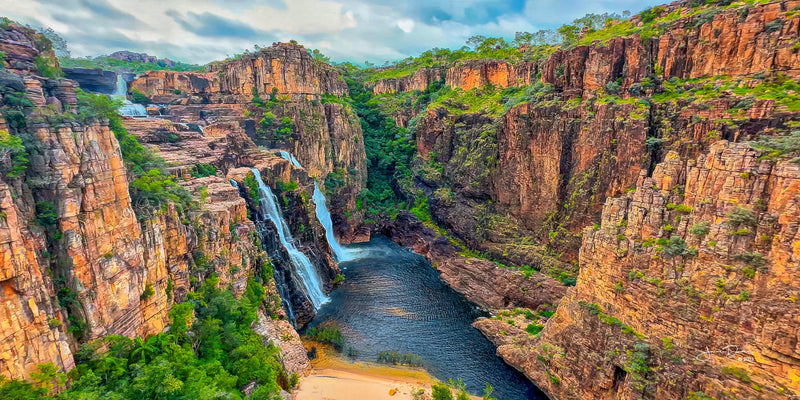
[406, 1, 800, 264]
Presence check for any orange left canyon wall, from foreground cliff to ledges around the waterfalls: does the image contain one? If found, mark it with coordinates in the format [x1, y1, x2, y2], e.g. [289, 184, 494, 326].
[0, 24, 330, 378]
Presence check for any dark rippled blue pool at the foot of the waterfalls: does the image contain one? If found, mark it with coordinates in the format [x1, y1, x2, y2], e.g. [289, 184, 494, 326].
[310, 238, 547, 400]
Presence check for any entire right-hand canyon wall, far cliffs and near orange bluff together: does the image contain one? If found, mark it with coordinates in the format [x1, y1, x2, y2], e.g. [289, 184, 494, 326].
[370, 1, 800, 399]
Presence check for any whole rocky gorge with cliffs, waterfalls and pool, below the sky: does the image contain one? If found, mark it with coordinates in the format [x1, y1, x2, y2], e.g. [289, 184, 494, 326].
[0, 0, 800, 400]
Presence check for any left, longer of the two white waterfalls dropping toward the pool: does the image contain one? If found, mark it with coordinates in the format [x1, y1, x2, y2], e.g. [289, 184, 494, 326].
[252, 168, 329, 310]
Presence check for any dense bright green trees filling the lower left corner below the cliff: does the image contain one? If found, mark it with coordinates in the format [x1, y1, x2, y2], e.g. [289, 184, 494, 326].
[0, 274, 296, 400]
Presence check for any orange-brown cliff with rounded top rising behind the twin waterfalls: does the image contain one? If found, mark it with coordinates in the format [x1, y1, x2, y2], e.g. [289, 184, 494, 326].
[131, 43, 367, 238]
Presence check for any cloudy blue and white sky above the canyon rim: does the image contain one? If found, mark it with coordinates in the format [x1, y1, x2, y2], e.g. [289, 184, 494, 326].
[0, 0, 666, 64]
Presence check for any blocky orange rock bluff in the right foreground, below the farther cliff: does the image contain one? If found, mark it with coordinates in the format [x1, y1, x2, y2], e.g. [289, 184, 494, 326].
[498, 141, 800, 399]
